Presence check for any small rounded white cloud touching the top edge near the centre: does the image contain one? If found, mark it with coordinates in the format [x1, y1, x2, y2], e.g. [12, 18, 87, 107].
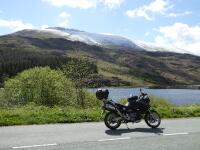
[101, 0, 125, 9]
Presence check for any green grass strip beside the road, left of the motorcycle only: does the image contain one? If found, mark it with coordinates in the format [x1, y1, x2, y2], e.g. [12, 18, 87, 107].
[0, 104, 102, 126]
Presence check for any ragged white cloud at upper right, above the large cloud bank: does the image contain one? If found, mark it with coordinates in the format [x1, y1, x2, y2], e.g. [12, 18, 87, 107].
[126, 0, 172, 20]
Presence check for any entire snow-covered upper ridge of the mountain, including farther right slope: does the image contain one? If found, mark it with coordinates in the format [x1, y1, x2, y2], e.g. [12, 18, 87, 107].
[15, 27, 194, 54]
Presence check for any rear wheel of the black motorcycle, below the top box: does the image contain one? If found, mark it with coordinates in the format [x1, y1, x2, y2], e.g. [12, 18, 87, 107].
[104, 112, 121, 130]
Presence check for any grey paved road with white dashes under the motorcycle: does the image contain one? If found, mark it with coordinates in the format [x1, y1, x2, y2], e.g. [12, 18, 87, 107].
[0, 118, 200, 150]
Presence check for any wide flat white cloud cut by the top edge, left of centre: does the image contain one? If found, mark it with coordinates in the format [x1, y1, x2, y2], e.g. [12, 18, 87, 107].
[42, 0, 97, 9]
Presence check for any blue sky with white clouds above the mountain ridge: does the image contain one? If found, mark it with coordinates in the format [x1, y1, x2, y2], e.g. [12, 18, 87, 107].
[0, 0, 200, 55]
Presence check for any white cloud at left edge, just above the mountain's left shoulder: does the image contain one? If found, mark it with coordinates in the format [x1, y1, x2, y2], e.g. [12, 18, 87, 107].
[0, 19, 35, 31]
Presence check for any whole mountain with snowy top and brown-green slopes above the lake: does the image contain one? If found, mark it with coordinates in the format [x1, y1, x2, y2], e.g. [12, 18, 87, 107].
[0, 28, 200, 86]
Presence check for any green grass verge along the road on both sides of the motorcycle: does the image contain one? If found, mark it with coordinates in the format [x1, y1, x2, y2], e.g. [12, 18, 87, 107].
[0, 96, 200, 126]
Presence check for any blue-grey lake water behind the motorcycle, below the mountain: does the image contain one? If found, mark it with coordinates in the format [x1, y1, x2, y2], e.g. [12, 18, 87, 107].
[90, 88, 200, 105]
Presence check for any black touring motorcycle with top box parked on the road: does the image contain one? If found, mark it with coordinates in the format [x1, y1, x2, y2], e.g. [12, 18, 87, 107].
[96, 89, 161, 130]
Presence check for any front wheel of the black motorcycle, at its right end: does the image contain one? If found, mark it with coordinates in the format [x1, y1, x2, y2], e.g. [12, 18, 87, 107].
[144, 110, 161, 128]
